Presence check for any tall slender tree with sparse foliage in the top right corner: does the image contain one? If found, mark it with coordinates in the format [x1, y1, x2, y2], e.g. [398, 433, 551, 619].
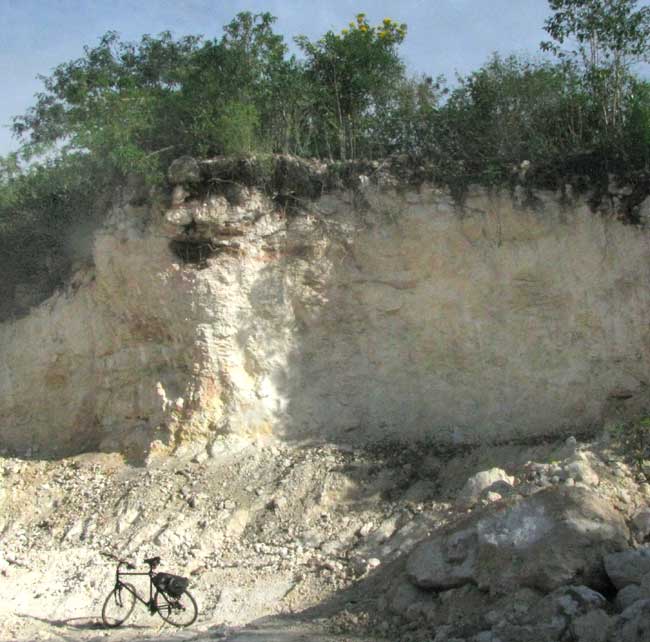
[541, 0, 650, 138]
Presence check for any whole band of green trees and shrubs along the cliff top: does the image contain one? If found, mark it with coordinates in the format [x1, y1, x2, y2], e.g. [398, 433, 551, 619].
[0, 0, 650, 316]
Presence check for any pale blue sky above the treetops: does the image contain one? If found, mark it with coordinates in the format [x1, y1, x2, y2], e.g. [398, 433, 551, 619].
[0, 0, 550, 155]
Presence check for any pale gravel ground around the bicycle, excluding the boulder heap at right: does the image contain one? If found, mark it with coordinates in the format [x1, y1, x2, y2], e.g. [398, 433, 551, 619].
[0, 436, 650, 642]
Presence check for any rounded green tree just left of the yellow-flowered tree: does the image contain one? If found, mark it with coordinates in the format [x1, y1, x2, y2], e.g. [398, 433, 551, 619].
[168, 12, 305, 155]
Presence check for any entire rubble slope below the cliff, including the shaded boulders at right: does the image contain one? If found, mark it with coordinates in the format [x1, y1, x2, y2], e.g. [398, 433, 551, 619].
[0, 428, 650, 642]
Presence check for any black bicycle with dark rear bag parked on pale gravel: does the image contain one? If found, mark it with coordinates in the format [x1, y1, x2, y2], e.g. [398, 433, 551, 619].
[102, 553, 198, 628]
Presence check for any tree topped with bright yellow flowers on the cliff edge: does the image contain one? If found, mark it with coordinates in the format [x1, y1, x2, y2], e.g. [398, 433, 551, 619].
[296, 13, 406, 159]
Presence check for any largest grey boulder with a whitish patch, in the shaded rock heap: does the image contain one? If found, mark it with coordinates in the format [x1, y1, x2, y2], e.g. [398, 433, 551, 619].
[406, 486, 629, 594]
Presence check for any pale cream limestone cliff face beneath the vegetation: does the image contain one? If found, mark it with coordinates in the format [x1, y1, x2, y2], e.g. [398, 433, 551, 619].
[0, 170, 650, 457]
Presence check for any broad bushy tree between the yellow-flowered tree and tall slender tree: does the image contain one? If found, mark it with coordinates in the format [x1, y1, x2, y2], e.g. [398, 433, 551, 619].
[430, 54, 597, 183]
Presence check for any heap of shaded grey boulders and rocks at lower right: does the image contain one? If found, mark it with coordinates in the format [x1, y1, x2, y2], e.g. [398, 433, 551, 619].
[374, 439, 650, 642]
